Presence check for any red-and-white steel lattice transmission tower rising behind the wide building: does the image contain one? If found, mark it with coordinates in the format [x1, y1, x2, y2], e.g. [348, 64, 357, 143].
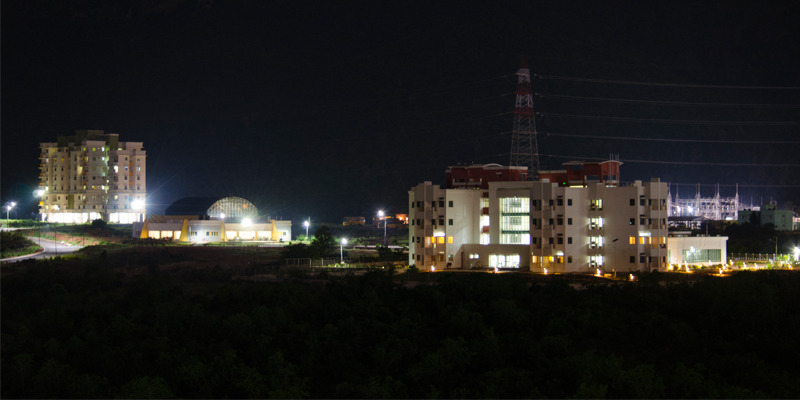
[508, 57, 539, 180]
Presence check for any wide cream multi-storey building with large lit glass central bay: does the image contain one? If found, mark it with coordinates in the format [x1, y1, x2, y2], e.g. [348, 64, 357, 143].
[409, 164, 669, 273]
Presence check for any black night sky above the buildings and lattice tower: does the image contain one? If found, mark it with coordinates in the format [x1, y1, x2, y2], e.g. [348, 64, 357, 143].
[2, 0, 800, 221]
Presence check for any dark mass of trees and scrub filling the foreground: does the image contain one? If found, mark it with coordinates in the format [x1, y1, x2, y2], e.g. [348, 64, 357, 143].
[2, 265, 800, 398]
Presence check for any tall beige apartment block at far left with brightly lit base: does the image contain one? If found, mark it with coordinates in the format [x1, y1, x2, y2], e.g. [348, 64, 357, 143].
[39, 130, 147, 223]
